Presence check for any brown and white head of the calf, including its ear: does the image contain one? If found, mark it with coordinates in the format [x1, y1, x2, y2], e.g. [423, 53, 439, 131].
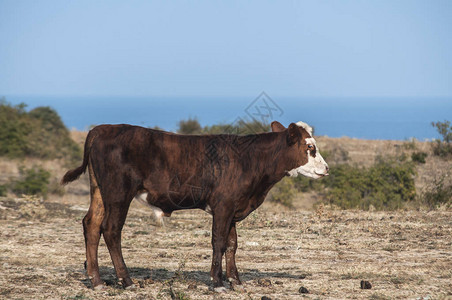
[271, 121, 329, 179]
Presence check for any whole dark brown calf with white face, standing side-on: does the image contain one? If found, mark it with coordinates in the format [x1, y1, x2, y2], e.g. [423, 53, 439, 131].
[62, 121, 328, 291]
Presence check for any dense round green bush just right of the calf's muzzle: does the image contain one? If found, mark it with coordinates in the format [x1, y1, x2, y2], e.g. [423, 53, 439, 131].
[323, 158, 416, 210]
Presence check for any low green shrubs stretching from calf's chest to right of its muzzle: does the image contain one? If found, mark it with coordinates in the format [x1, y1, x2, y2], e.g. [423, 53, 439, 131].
[269, 156, 416, 210]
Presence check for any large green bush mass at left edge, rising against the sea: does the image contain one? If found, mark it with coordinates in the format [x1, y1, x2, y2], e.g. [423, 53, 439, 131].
[0, 100, 82, 162]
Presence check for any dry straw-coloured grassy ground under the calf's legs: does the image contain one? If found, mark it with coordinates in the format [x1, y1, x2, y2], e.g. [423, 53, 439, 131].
[0, 194, 452, 299]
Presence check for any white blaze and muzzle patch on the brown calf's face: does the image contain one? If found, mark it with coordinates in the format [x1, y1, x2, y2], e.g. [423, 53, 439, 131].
[287, 137, 328, 179]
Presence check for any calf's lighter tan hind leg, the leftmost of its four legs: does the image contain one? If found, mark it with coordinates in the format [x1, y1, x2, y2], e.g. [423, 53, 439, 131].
[83, 164, 105, 289]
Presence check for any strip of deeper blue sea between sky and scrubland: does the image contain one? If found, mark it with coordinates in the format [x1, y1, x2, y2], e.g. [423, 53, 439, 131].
[4, 93, 452, 141]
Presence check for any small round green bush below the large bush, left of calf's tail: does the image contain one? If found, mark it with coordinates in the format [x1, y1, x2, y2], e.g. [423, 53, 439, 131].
[12, 166, 50, 197]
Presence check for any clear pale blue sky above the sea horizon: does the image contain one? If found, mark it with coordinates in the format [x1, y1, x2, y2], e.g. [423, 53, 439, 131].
[0, 0, 452, 98]
